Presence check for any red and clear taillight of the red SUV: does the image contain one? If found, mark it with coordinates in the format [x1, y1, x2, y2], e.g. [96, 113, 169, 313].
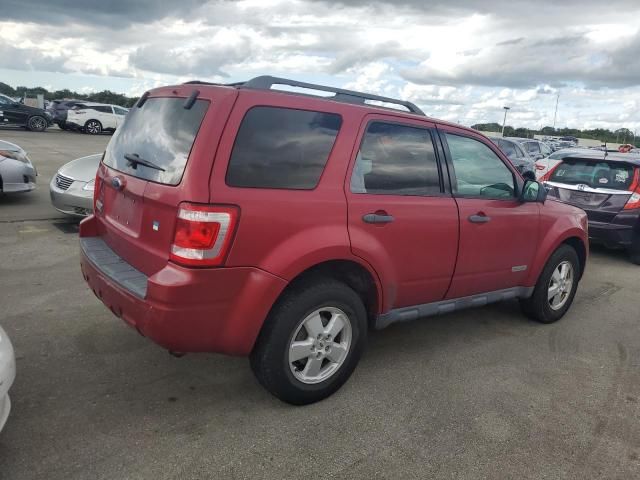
[170, 203, 240, 266]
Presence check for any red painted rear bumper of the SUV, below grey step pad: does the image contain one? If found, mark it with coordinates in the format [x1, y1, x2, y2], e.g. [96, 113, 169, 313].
[80, 217, 286, 355]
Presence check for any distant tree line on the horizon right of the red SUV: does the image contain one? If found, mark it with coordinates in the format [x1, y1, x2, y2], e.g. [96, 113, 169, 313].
[471, 123, 640, 147]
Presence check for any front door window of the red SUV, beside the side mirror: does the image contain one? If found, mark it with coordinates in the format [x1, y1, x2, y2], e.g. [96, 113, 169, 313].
[446, 133, 515, 198]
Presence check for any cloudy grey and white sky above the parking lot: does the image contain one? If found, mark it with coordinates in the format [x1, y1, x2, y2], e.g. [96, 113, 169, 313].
[0, 0, 640, 132]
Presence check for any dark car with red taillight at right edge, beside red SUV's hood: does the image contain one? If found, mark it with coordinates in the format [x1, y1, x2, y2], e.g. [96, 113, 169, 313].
[541, 150, 640, 264]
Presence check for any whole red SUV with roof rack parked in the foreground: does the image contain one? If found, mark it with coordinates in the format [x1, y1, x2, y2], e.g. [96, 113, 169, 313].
[80, 77, 588, 404]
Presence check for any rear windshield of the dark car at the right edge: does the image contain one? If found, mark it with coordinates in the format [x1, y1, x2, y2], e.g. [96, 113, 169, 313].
[550, 159, 633, 190]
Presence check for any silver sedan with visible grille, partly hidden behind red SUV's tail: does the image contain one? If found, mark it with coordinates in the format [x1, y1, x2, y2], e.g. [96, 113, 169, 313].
[49, 153, 102, 217]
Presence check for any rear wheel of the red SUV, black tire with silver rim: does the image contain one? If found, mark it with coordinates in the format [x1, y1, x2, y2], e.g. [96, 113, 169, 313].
[250, 277, 367, 405]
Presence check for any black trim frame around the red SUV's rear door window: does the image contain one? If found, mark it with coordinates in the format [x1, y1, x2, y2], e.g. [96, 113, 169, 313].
[345, 115, 444, 197]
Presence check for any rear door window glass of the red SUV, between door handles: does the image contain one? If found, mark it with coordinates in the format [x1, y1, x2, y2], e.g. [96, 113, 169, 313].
[351, 122, 440, 195]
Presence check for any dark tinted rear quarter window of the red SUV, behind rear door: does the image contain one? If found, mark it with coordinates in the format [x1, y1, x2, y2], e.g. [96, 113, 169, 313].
[226, 107, 342, 190]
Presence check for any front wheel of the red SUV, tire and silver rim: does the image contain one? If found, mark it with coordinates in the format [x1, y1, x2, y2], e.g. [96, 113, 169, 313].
[520, 245, 580, 323]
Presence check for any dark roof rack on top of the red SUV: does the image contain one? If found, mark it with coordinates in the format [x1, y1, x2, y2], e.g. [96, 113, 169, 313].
[185, 75, 425, 116]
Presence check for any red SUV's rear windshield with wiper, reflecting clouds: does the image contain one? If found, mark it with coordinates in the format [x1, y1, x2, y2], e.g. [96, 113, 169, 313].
[104, 98, 209, 185]
